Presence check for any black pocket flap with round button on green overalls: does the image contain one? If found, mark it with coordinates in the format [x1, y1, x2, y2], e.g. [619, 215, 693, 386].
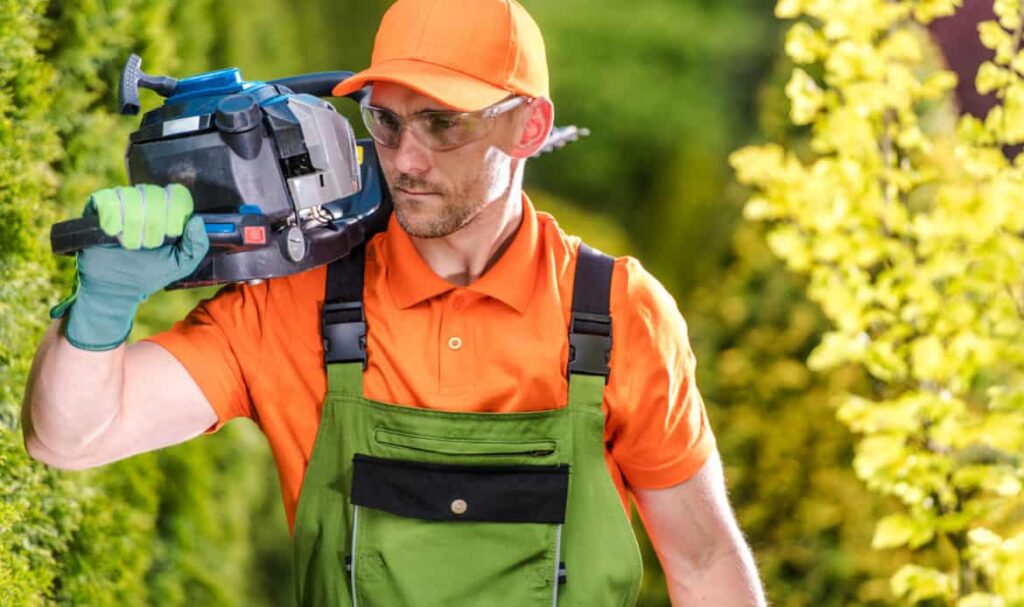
[351, 453, 569, 524]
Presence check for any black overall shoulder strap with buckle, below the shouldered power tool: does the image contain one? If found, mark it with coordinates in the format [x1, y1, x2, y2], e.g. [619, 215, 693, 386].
[321, 243, 367, 370]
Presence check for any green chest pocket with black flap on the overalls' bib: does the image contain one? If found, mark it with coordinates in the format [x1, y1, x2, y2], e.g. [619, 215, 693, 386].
[351, 450, 569, 607]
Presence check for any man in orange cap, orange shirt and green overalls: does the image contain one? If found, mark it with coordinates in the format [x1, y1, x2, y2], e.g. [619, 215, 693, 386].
[26, 0, 764, 607]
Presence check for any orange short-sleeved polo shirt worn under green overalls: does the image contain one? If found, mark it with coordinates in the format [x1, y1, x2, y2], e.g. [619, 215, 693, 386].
[150, 197, 715, 527]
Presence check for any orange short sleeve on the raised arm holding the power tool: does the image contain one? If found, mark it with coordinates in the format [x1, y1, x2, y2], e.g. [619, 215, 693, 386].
[144, 283, 267, 432]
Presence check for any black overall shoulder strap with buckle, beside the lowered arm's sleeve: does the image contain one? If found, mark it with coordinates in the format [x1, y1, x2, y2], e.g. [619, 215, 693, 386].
[568, 244, 615, 384]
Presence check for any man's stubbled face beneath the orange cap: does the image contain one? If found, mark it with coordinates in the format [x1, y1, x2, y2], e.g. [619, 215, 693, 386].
[371, 82, 516, 239]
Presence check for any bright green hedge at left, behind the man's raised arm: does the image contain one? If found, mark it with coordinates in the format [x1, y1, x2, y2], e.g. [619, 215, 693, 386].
[0, 0, 287, 606]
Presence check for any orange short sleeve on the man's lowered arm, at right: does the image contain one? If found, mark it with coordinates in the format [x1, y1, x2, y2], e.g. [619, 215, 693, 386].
[604, 257, 716, 489]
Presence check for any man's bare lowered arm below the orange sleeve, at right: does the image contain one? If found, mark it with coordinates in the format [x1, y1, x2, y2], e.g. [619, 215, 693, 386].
[633, 453, 766, 607]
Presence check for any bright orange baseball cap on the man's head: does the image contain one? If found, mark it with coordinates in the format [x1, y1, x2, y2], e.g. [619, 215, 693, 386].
[333, 0, 549, 111]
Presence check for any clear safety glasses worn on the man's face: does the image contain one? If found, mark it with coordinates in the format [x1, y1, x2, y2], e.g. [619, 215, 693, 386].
[359, 95, 534, 151]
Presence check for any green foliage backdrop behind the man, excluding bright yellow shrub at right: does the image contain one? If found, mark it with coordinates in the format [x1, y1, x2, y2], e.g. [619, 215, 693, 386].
[0, 0, 974, 607]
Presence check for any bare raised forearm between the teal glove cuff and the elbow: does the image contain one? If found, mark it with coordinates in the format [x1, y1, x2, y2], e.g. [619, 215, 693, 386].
[23, 320, 125, 465]
